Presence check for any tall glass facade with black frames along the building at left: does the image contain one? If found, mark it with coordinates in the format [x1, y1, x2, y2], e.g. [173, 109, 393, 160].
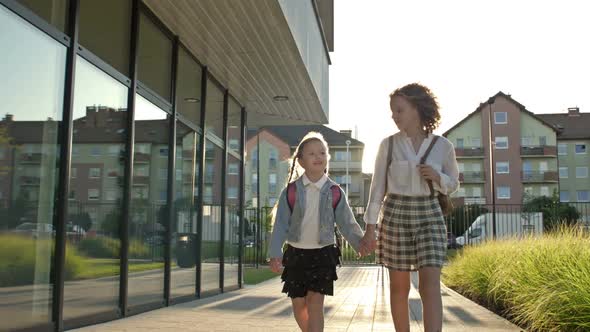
[0, 0, 244, 331]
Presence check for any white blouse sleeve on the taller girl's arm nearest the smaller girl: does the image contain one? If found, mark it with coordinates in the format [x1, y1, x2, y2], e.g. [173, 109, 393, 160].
[363, 138, 390, 224]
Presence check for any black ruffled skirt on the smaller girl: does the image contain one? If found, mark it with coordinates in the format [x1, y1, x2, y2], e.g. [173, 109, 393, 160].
[281, 244, 339, 298]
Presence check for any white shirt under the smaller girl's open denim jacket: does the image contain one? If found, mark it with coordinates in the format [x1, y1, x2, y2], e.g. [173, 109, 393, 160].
[289, 174, 328, 249]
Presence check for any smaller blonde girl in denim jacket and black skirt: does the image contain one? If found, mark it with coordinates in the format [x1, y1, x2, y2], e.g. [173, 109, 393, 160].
[270, 132, 366, 332]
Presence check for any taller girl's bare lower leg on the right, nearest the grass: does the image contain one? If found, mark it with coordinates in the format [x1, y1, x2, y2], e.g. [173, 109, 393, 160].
[419, 267, 442, 332]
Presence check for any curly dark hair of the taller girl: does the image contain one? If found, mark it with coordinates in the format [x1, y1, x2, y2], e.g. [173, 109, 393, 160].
[389, 83, 440, 133]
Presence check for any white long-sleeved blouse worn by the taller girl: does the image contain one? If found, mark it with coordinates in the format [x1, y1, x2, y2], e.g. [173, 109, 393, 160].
[364, 132, 459, 224]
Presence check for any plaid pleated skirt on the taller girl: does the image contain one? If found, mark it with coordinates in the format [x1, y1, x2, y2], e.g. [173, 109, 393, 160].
[376, 194, 447, 271]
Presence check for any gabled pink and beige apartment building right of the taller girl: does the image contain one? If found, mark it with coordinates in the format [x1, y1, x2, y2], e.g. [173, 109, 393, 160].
[443, 91, 559, 204]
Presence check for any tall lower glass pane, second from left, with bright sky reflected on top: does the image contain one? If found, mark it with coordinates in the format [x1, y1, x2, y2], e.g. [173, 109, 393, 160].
[64, 57, 128, 320]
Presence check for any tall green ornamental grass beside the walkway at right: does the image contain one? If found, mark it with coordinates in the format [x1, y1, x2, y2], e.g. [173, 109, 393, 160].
[443, 227, 590, 331]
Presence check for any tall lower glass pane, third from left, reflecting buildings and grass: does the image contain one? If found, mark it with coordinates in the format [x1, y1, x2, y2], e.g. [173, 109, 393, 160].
[128, 95, 170, 305]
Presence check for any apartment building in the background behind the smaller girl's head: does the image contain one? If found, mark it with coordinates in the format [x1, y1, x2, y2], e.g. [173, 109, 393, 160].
[244, 125, 366, 207]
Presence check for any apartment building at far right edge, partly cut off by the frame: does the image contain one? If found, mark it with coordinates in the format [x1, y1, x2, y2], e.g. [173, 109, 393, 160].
[538, 107, 590, 202]
